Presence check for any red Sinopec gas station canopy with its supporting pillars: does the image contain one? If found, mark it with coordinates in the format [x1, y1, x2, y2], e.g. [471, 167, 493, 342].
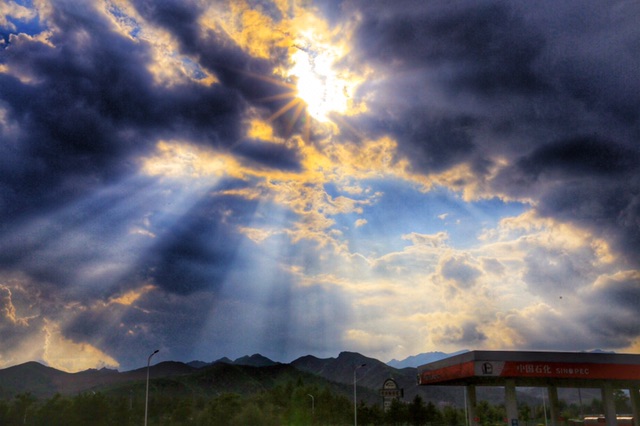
[418, 351, 640, 426]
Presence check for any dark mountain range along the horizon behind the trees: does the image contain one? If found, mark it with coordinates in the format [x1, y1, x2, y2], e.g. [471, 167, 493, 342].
[0, 352, 588, 407]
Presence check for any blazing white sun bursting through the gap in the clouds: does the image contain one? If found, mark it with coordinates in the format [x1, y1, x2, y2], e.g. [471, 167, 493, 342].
[288, 33, 354, 122]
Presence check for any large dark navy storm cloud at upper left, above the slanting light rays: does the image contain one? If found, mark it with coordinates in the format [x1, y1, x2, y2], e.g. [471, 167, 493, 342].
[0, 4, 235, 220]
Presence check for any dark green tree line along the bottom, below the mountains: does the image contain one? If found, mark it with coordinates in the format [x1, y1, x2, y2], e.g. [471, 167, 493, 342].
[0, 380, 628, 426]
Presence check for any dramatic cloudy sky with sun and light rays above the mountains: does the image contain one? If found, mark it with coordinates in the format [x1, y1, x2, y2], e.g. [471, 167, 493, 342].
[0, 0, 640, 371]
